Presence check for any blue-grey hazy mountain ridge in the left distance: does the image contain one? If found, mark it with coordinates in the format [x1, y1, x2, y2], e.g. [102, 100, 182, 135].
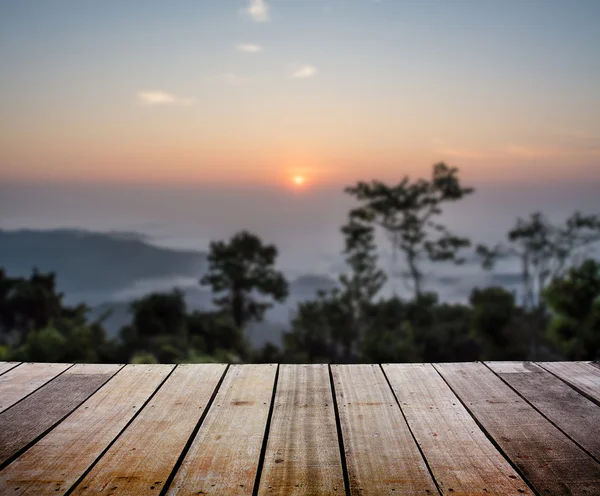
[0, 229, 206, 303]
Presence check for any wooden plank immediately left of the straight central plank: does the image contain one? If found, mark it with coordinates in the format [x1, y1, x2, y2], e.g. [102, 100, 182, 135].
[167, 365, 277, 496]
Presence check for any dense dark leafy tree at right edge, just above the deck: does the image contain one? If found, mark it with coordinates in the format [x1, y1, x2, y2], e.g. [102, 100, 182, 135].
[544, 259, 600, 360]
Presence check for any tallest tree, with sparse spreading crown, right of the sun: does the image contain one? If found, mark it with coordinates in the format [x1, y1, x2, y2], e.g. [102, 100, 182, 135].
[346, 162, 474, 300]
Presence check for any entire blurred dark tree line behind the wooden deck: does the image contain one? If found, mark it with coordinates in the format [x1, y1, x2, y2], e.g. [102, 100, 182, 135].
[0, 163, 600, 363]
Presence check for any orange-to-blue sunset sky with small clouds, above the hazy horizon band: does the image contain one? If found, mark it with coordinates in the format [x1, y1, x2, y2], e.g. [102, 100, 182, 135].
[0, 0, 600, 190]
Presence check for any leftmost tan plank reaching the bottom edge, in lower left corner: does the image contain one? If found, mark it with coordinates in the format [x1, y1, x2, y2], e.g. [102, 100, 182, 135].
[0, 365, 173, 496]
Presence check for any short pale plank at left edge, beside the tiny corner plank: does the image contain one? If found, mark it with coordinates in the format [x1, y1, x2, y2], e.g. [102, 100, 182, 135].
[0, 363, 72, 412]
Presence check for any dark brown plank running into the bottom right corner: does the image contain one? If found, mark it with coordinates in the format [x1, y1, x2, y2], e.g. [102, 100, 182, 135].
[435, 363, 600, 495]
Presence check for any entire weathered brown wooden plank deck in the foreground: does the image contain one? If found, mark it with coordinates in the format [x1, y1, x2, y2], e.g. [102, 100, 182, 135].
[0, 362, 600, 496]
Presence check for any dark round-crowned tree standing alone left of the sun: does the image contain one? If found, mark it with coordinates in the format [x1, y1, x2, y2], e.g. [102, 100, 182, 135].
[200, 231, 288, 329]
